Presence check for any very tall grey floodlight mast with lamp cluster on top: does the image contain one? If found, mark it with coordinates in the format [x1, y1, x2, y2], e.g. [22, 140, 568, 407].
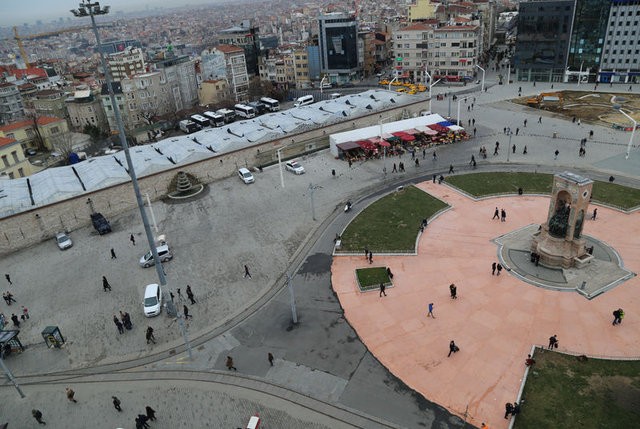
[71, 0, 192, 359]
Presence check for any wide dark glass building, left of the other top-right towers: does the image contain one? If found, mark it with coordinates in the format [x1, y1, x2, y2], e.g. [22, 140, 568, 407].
[513, 0, 580, 82]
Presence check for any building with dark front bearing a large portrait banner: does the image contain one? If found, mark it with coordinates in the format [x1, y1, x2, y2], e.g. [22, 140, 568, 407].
[318, 12, 360, 84]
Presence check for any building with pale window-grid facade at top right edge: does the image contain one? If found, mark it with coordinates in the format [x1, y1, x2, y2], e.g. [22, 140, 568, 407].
[598, 0, 640, 83]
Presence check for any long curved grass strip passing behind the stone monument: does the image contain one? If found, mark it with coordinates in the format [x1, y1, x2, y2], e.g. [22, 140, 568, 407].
[447, 173, 640, 209]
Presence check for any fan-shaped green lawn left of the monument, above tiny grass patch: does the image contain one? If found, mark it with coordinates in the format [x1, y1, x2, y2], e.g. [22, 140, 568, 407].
[342, 186, 447, 252]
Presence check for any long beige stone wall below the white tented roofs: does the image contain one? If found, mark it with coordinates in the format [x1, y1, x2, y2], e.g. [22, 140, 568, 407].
[0, 100, 425, 255]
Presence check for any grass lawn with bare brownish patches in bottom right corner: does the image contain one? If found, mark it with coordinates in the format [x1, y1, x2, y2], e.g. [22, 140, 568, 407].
[515, 348, 640, 429]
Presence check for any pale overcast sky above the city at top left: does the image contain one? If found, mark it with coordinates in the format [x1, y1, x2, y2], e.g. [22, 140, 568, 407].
[0, 0, 215, 27]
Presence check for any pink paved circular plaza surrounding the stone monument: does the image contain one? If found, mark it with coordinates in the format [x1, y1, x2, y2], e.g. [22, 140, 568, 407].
[332, 182, 640, 428]
